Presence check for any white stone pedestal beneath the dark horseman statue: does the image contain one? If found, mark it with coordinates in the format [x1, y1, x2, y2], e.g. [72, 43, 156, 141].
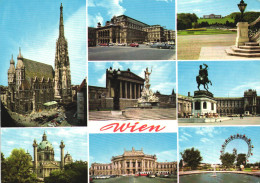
[192, 90, 217, 118]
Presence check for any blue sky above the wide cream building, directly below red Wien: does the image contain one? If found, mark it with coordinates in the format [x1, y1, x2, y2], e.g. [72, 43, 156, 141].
[89, 133, 177, 166]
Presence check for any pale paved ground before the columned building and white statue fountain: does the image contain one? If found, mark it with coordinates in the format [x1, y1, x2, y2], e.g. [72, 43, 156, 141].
[89, 108, 176, 121]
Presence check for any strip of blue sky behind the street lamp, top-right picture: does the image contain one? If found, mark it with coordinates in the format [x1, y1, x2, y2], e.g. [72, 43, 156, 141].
[177, 0, 260, 17]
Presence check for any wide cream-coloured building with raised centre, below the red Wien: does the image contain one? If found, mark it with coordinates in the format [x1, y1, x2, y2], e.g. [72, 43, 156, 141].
[89, 148, 177, 175]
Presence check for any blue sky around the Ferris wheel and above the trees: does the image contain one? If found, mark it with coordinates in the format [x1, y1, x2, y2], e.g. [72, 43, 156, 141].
[179, 127, 260, 164]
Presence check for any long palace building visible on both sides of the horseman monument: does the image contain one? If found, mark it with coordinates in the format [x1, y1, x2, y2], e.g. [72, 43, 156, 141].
[178, 89, 260, 117]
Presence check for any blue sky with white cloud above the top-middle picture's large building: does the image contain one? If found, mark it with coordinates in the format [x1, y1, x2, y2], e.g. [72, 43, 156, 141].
[88, 0, 175, 30]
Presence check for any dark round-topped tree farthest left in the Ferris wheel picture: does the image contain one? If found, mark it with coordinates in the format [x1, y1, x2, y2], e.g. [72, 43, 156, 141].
[181, 147, 203, 170]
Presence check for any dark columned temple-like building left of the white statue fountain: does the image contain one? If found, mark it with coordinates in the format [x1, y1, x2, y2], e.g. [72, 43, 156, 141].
[88, 68, 144, 110]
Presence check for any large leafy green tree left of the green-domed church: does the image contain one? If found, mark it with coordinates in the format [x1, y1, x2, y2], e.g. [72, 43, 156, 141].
[1, 149, 37, 183]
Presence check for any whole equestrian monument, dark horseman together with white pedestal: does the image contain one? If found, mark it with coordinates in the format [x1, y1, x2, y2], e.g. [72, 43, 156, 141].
[192, 64, 217, 118]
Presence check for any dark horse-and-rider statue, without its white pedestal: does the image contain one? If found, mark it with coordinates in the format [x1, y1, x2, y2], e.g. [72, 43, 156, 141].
[196, 64, 212, 91]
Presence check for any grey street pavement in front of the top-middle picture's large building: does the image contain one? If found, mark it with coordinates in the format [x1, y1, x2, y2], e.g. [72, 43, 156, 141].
[88, 45, 176, 61]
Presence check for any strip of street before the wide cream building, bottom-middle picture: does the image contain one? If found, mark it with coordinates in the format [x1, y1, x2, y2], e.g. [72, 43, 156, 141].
[93, 176, 177, 183]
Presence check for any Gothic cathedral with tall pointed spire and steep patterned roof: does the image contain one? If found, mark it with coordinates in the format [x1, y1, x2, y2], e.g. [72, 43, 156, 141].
[6, 4, 71, 113]
